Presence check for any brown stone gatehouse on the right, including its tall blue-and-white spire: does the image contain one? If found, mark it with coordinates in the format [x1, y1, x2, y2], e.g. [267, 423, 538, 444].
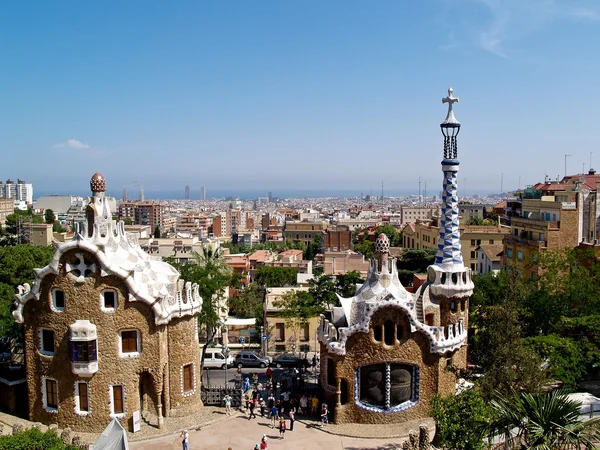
[318, 90, 473, 426]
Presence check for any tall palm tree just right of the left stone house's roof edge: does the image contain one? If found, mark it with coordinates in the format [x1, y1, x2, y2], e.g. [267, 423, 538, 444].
[175, 246, 232, 372]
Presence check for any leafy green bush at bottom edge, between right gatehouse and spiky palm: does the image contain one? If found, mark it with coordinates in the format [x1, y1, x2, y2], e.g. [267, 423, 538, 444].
[431, 389, 491, 450]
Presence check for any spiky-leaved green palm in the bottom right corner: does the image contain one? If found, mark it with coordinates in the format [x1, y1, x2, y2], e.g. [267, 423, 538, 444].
[490, 390, 600, 450]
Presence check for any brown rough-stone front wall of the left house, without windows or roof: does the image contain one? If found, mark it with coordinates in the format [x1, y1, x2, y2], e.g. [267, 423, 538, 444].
[24, 252, 201, 432]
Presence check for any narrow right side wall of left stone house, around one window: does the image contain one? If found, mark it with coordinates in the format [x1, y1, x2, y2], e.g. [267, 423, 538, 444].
[168, 317, 202, 416]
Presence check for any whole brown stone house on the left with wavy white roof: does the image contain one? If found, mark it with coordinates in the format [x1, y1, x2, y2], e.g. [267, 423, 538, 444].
[14, 174, 202, 432]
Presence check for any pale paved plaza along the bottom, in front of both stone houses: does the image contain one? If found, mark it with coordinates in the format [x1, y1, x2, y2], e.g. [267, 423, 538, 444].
[129, 412, 402, 450]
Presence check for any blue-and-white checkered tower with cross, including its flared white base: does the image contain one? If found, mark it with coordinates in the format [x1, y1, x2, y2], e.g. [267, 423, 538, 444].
[428, 88, 473, 298]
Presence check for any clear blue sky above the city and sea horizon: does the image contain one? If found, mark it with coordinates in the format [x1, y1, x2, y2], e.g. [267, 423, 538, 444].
[0, 0, 600, 195]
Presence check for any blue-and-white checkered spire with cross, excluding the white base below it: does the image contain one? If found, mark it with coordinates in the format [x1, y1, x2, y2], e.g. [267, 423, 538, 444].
[435, 88, 463, 266]
